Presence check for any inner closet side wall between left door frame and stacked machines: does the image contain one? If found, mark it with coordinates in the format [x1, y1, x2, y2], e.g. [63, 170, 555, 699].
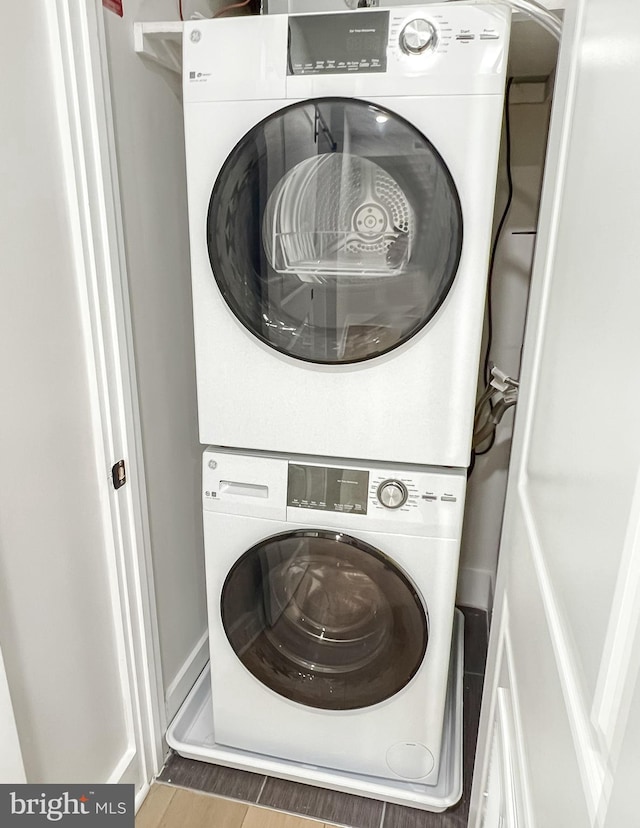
[104, 0, 207, 718]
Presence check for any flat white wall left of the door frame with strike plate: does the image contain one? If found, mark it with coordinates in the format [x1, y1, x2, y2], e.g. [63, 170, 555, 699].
[0, 0, 138, 782]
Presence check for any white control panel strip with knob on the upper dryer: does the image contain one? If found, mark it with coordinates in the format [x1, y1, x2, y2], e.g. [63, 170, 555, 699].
[183, 3, 511, 105]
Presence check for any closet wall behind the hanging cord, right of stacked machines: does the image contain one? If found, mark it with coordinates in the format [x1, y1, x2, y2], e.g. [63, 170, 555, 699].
[458, 97, 550, 608]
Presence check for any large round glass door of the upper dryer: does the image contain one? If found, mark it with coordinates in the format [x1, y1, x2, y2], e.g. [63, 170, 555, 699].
[207, 98, 462, 364]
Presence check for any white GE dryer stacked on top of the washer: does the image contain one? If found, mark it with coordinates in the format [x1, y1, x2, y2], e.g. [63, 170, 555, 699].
[183, 3, 509, 467]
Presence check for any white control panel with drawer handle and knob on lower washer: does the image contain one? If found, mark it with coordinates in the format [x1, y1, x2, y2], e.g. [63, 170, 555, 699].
[202, 447, 467, 540]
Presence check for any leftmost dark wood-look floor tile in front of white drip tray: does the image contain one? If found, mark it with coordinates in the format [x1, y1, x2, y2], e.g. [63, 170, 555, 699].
[158, 754, 265, 802]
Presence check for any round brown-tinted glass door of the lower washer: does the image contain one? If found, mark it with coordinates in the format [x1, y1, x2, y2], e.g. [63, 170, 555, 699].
[221, 530, 428, 710]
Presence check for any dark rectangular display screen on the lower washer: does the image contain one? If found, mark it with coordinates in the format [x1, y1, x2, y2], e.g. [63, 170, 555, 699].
[287, 463, 369, 515]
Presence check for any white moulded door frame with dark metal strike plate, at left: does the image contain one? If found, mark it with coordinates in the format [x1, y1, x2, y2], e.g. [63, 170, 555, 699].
[47, 0, 167, 805]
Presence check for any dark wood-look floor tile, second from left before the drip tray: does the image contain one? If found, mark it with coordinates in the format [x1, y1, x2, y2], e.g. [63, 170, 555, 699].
[259, 778, 383, 828]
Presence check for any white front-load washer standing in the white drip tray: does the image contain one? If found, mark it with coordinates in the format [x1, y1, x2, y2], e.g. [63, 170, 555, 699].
[203, 449, 465, 785]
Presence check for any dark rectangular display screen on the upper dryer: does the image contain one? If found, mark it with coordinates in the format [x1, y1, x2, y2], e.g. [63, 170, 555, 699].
[287, 11, 389, 75]
